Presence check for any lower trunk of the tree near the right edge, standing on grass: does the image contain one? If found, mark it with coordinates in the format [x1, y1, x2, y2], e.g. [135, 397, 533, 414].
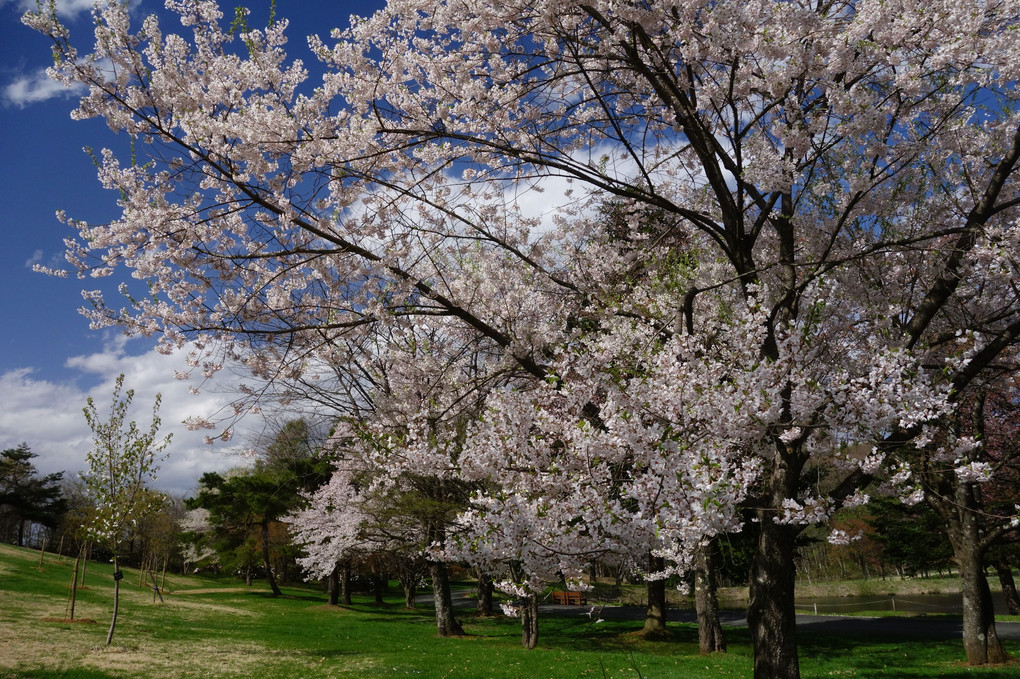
[957, 550, 1009, 665]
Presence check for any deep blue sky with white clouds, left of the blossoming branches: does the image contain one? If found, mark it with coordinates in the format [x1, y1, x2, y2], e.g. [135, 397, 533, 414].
[0, 0, 379, 493]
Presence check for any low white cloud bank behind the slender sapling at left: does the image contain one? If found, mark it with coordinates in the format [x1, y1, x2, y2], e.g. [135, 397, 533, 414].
[0, 340, 262, 494]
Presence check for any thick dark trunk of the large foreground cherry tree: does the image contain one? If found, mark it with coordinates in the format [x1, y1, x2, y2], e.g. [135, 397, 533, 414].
[748, 501, 801, 679]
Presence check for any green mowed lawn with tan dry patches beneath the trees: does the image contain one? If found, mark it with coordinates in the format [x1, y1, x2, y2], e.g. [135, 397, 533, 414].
[0, 545, 1020, 679]
